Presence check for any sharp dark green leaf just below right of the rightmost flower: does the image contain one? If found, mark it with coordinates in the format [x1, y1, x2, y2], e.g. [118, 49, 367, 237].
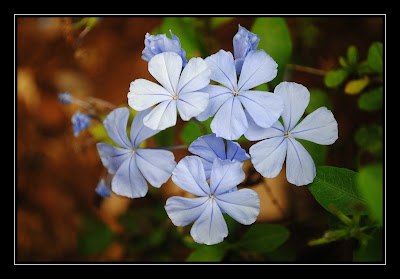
[308, 166, 365, 215]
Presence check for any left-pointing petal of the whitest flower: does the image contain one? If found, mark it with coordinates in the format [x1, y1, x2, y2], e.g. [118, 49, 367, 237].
[128, 79, 172, 111]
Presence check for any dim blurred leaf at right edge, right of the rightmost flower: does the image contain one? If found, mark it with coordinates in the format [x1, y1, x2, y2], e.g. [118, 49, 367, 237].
[354, 125, 383, 160]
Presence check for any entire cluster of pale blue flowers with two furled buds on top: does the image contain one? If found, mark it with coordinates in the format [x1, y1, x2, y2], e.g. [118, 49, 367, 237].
[93, 25, 338, 245]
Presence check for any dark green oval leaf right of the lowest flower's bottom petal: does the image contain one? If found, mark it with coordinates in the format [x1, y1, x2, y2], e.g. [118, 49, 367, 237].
[236, 224, 290, 253]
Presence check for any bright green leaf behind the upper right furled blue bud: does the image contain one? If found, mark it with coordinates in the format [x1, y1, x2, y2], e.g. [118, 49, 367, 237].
[250, 17, 292, 86]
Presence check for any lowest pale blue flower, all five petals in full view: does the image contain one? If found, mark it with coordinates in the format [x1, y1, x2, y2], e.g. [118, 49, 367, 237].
[165, 156, 260, 245]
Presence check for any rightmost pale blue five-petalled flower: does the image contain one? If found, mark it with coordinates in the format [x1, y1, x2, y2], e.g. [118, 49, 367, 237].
[244, 82, 338, 186]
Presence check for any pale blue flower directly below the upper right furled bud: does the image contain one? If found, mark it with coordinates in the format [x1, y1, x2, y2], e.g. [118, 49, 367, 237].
[196, 50, 283, 140]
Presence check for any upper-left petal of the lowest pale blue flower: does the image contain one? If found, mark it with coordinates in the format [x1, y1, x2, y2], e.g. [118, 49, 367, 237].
[172, 156, 210, 196]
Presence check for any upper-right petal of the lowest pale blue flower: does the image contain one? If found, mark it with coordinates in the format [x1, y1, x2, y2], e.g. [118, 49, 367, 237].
[210, 158, 246, 195]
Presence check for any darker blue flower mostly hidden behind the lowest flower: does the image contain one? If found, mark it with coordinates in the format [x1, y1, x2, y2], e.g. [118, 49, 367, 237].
[188, 134, 250, 179]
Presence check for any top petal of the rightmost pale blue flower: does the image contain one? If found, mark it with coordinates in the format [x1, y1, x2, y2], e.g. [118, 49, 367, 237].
[274, 81, 310, 131]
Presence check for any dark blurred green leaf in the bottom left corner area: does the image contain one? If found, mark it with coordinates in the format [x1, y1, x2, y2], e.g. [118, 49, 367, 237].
[78, 215, 114, 256]
